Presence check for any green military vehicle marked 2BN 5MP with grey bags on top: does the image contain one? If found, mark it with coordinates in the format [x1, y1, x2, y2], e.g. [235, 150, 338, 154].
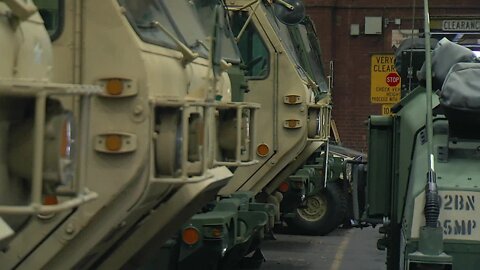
[352, 1, 480, 270]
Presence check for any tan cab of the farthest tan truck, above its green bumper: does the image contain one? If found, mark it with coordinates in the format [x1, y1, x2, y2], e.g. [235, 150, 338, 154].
[221, 1, 330, 194]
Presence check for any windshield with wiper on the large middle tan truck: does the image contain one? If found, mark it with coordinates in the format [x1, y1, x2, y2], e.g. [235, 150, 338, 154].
[119, 0, 208, 57]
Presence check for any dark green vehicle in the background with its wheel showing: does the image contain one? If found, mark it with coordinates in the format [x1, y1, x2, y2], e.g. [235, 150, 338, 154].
[278, 144, 366, 235]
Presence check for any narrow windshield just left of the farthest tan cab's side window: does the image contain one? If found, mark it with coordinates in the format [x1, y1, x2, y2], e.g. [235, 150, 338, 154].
[193, 0, 240, 64]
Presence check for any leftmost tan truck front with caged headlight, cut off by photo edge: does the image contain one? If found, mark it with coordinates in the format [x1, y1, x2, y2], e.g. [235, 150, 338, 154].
[0, 0, 100, 251]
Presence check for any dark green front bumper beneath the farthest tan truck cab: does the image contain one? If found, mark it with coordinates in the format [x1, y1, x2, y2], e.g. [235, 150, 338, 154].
[175, 192, 275, 269]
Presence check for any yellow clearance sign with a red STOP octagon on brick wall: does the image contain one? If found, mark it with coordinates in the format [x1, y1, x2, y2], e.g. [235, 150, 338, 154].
[370, 54, 401, 104]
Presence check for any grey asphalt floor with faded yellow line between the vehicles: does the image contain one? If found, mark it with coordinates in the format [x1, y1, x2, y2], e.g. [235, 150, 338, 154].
[259, 228, 386, 270]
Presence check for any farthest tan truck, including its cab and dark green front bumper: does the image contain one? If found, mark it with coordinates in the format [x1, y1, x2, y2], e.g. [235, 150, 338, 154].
[162, 0, 331, 269]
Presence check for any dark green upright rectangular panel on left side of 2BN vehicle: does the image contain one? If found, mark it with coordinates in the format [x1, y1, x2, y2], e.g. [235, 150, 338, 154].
[367, 115, 393, 217]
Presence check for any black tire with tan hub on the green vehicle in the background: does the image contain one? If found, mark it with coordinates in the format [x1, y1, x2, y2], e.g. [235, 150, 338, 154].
[286, 183, 348, 235]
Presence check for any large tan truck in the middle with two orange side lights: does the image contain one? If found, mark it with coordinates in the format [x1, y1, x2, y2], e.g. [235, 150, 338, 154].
[0, 0, 257, 269]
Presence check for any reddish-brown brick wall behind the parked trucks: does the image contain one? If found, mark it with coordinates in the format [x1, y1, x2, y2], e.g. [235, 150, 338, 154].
[305, 0, 480, 152]
